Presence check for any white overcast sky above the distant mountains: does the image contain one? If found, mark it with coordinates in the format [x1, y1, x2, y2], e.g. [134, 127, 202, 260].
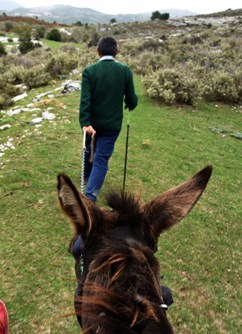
[15, 0, 242, 14]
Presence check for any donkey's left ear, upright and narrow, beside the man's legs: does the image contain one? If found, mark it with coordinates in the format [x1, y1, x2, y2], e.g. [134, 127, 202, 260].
[57, 174, 92, 236]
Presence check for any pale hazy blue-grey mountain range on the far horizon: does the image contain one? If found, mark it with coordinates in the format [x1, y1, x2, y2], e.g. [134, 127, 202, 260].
[5, 5, 195, 24]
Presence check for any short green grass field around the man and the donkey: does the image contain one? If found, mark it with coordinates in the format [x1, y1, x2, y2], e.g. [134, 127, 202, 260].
[0, 78, 242, 334]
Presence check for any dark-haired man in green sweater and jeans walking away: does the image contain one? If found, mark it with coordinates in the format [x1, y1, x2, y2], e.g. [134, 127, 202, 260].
[79, 37, 138, 202]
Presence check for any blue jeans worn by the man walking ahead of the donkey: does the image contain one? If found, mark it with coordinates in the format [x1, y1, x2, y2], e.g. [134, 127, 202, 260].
[84, 131, 119, 202]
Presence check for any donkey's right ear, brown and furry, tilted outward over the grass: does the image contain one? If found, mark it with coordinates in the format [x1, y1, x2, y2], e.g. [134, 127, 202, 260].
[144, 166, 212, 239]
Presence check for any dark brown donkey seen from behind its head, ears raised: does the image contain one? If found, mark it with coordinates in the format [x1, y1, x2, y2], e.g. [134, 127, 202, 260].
[58, 166, 212, 334]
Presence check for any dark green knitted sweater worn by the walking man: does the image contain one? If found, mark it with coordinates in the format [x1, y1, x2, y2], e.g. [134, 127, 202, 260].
[79, 57, 138, 132]
